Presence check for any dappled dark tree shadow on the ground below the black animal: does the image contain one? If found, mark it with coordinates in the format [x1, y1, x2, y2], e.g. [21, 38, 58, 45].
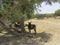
[0, 32, 52, 45]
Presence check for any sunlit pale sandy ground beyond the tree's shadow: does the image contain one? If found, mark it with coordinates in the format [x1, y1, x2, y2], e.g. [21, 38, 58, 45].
[1, 18, 60, 45]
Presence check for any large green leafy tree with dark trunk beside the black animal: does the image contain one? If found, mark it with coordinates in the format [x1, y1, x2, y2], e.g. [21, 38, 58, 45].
[2, 0, 58, 32]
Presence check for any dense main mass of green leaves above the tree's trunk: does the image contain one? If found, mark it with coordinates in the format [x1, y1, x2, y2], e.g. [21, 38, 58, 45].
[3, 0, 34, 20]
